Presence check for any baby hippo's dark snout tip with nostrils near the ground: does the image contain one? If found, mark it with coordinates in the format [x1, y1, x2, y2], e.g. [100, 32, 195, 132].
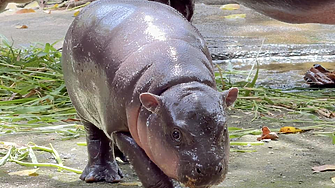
[181, 160, 227, 188]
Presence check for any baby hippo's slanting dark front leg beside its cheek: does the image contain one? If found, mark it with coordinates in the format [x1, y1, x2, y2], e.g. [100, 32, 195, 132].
[113, 132, 173, 188]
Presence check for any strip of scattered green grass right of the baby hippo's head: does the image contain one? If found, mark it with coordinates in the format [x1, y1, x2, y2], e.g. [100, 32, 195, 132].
[215, 63, 335, 120]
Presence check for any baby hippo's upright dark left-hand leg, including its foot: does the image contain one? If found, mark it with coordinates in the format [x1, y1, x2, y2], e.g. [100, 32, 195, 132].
[80, 120, 123, 182]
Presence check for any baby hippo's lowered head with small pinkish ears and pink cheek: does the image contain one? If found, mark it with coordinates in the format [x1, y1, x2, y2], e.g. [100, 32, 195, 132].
[139, 83, 238, 187]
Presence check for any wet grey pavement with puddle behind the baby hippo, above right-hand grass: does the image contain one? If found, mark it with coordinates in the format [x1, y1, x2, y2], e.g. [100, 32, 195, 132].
[193, 4, 335, 89]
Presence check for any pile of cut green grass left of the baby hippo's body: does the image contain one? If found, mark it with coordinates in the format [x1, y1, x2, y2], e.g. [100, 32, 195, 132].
[0, 36, 76, 135]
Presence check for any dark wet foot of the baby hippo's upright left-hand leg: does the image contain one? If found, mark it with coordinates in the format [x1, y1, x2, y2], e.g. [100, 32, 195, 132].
[80, 161, 123, 183]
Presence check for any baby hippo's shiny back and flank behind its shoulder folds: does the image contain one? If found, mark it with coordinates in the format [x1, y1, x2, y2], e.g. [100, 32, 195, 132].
[62, 0, 210, 135]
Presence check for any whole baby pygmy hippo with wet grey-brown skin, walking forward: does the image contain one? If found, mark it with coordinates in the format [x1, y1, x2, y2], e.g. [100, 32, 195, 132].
[62, 0, 238, 188]
